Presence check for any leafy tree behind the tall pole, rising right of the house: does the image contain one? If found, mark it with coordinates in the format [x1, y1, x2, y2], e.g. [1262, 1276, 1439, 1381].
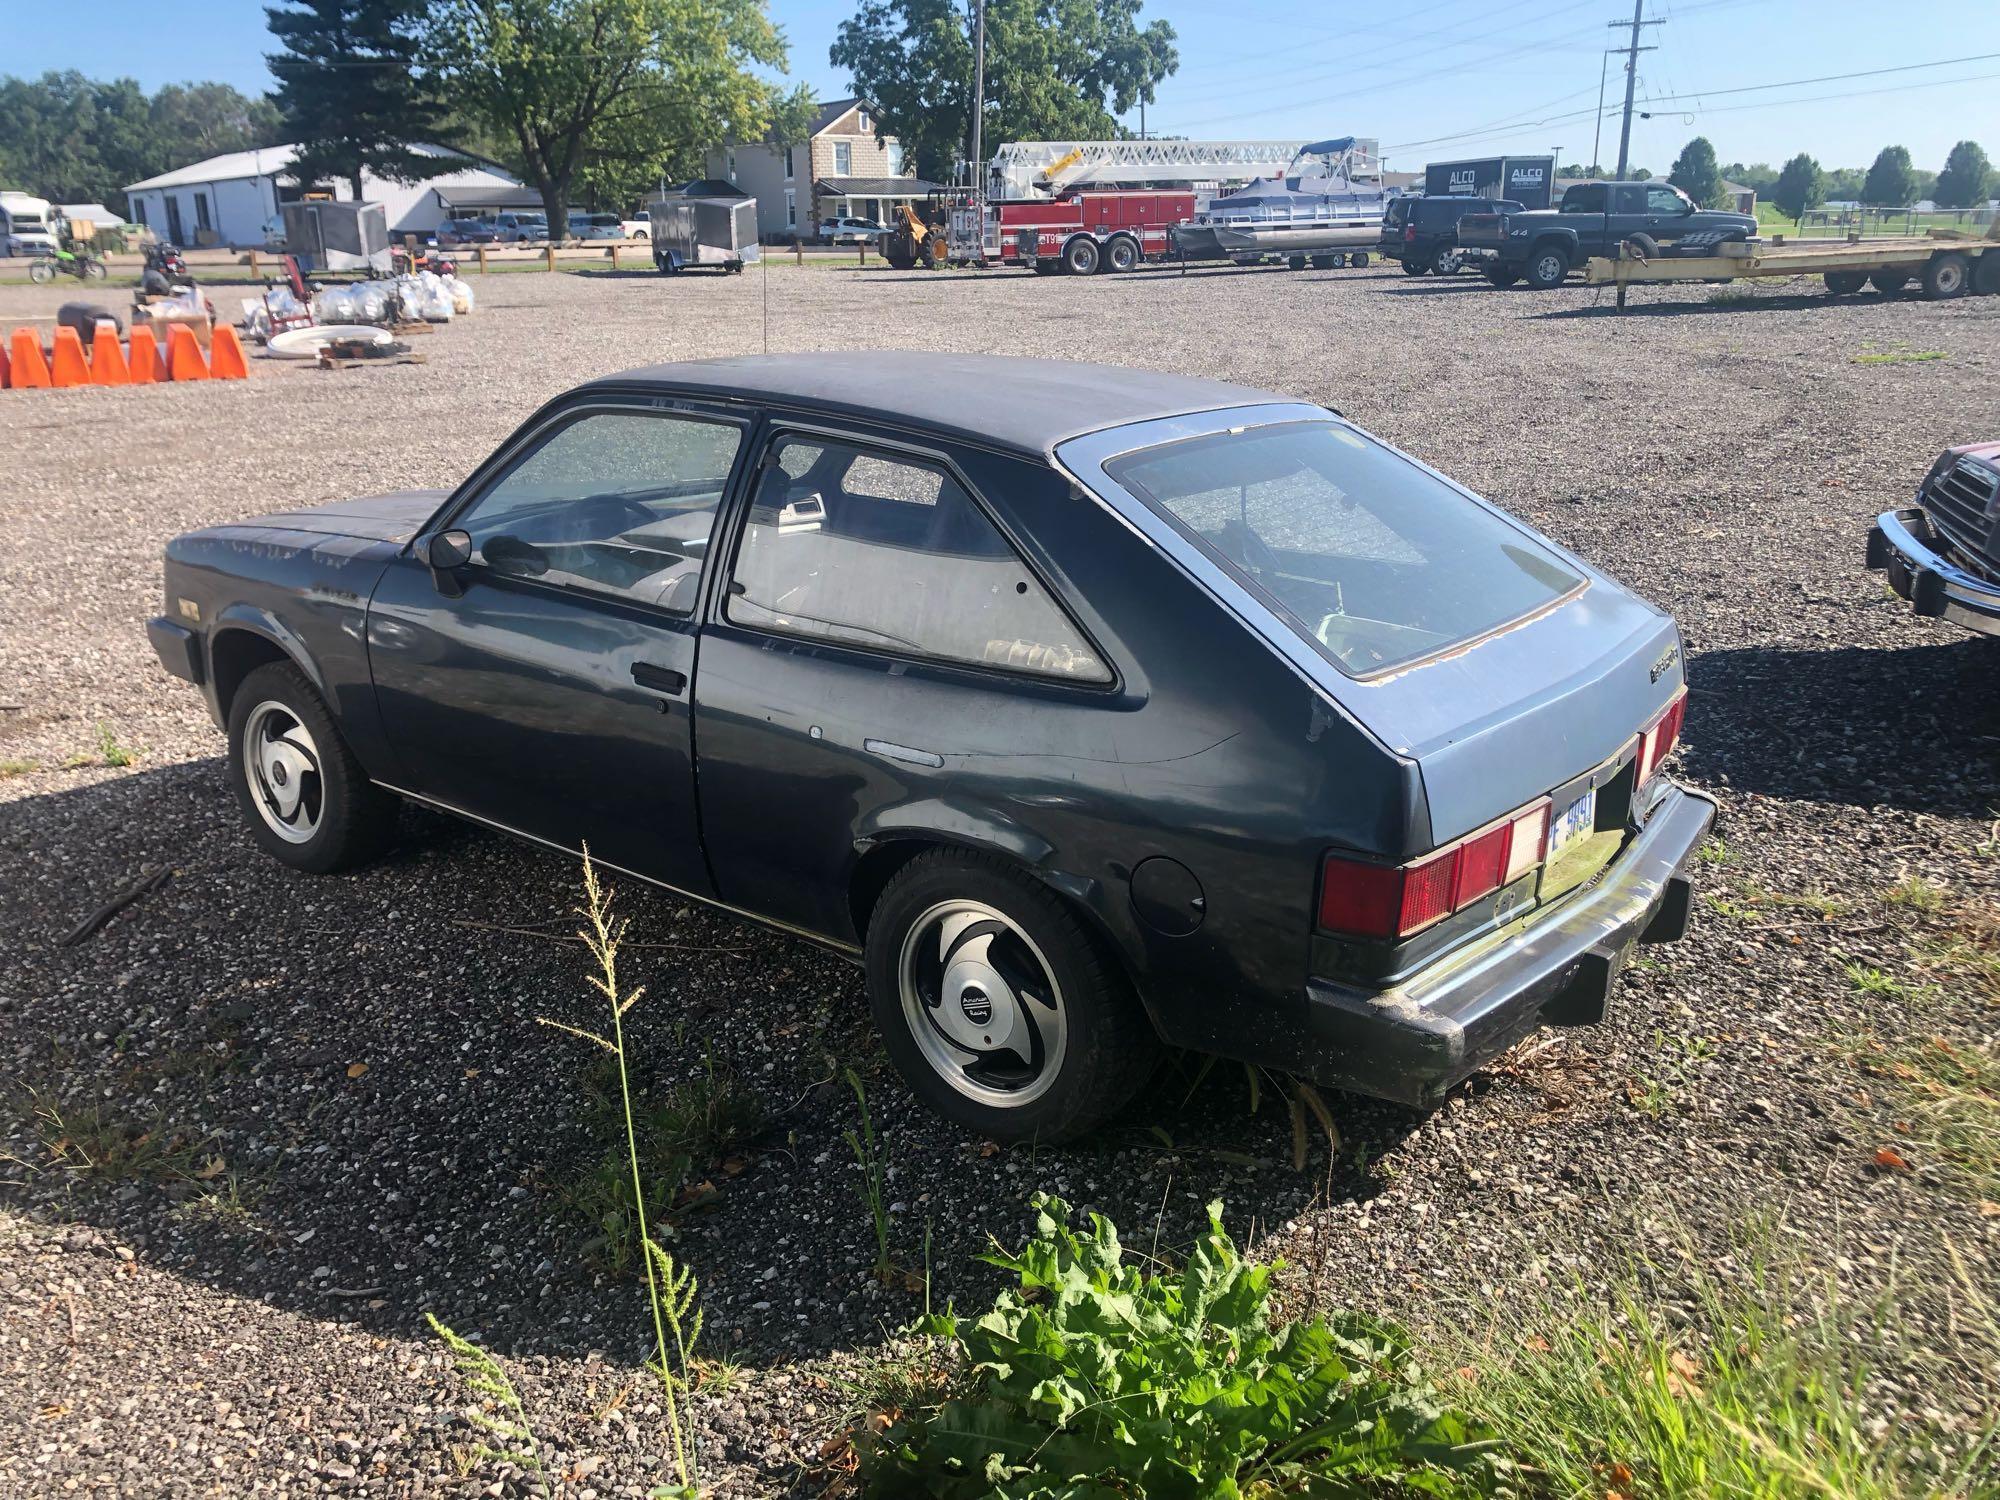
[832, 0, 1180, 178]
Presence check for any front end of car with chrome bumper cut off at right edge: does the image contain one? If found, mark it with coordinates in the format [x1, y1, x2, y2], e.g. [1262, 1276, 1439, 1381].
[1868, 442, 2000, 636]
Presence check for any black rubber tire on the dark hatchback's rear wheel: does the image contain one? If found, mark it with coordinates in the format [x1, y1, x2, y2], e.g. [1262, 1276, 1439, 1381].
[866, 850, 1160, 1142]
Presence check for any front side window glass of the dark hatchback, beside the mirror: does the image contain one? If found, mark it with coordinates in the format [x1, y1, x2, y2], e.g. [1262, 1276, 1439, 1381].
[456, 410, 744, 614]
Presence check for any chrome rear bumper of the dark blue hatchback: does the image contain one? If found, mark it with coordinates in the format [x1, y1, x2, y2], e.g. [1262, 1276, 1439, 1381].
[1304, 786, 1716, 1104]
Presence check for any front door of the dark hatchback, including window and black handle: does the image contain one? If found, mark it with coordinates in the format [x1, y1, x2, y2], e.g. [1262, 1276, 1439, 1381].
[368, 398, 748, 894]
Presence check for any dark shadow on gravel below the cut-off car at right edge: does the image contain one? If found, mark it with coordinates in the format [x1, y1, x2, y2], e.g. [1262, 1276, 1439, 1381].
[1686, 634, 2000, 818]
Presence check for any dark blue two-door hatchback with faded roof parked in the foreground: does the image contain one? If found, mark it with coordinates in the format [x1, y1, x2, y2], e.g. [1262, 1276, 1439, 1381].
[150, 352, 1714, 1140]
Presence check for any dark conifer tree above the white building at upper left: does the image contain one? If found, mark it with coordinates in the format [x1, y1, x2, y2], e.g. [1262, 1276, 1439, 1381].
[264, 0, 460, 198]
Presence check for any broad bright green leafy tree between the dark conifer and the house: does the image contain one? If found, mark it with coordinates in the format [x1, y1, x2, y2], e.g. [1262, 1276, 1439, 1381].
[424, 0, 786, 232]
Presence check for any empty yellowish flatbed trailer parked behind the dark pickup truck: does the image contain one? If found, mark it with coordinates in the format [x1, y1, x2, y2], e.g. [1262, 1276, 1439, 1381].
[1584, 222, 2000, 306]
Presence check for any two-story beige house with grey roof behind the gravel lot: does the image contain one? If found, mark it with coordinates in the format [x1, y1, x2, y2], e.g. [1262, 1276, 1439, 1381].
[704, 98, 934, 242]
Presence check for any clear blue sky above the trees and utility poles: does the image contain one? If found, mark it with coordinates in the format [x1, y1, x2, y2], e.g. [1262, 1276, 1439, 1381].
[0, 0, 2000, 172]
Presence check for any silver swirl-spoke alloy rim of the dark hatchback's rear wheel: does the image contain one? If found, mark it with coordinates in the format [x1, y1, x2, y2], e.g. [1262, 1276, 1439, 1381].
[896, 898, 1070, 1110]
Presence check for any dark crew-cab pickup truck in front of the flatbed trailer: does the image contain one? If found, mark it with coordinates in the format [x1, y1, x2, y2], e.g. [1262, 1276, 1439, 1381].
[1458, 182, 1756, 290]
